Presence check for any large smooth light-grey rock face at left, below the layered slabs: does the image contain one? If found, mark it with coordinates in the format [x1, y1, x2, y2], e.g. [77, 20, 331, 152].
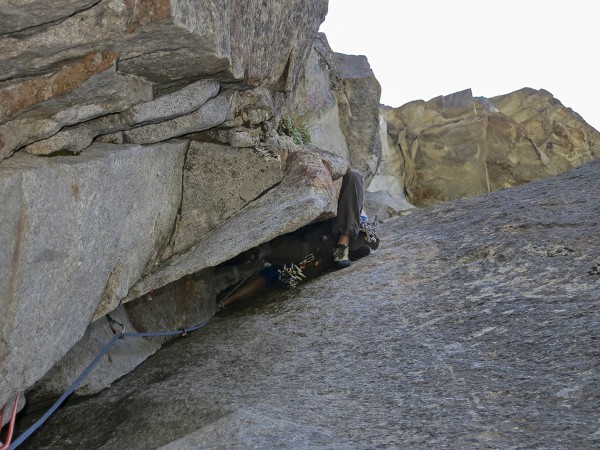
[0, 141, 187, 403]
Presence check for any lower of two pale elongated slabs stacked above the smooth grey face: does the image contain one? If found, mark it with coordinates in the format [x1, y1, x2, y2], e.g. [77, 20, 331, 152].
[123, 94, 230, 144]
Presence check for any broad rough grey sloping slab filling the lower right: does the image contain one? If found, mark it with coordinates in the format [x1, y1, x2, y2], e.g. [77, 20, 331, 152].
[17, 161, 600, 449]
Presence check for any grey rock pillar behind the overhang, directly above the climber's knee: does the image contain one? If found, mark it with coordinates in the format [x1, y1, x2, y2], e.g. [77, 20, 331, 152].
[288, 33, 381, 185]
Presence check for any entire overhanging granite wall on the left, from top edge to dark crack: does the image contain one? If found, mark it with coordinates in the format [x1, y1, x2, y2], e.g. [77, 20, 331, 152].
[0, 0, 332, 405]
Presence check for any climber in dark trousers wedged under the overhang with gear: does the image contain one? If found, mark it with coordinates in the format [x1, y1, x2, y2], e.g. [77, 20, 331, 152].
[217, 169, 379, 309]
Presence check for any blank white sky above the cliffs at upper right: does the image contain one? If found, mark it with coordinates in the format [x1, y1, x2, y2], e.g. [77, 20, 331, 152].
[320, 0, 600, 130]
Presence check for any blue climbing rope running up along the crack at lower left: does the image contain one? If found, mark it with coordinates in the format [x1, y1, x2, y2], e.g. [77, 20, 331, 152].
[8, 321, 208, 450]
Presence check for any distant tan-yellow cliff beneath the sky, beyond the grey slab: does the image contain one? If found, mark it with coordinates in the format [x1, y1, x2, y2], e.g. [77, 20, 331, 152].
[382, 88, 600, 206]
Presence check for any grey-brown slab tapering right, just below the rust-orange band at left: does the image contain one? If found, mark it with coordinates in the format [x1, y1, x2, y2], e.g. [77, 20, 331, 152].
[0, 65, 152, 160]
